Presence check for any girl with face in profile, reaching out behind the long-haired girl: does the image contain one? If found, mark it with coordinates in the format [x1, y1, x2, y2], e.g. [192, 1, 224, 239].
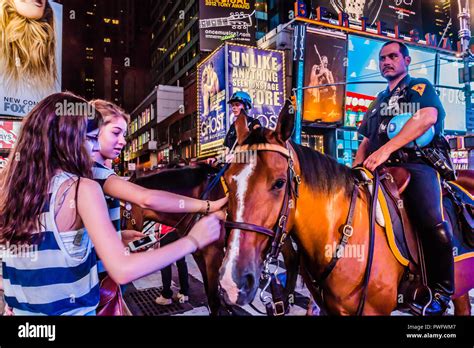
[87, 99, 227, 256]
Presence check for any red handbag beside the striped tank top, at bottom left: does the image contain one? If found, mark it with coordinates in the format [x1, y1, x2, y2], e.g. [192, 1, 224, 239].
[97, 276, 132, 316]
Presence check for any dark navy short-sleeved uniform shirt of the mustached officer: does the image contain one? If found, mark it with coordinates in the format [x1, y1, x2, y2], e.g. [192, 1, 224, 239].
[359, 75, 446, 153]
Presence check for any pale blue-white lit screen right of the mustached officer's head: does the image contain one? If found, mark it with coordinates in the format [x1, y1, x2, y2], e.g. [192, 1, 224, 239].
[438, 56, 466, 131]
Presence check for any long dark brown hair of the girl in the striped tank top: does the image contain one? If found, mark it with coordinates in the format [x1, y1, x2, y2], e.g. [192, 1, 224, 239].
[0, 93, 92, 244]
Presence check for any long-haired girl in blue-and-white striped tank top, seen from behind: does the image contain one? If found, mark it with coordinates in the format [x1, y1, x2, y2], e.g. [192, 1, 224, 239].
[0, 93, 223, 315]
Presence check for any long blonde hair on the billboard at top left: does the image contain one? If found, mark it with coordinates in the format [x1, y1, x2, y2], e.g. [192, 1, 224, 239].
[0, 0, 57, 90]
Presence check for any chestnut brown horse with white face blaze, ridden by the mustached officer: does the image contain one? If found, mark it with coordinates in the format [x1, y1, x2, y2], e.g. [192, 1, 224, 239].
[219, 103, 474, 315]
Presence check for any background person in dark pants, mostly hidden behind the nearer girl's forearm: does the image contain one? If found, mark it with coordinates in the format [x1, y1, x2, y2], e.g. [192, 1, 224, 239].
[155, 224, 189, 305]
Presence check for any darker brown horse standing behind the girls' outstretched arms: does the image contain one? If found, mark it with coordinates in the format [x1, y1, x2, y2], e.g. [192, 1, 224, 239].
[122, 164, 299, 316]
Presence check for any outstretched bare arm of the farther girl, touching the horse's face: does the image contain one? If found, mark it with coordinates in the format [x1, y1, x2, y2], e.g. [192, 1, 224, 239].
[104, 175, 227, 213]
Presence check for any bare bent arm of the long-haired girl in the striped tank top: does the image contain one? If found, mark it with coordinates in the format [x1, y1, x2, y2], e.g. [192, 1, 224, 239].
[77, 179, 223, 284]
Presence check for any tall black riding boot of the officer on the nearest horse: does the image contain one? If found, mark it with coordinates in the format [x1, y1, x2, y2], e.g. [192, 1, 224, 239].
[410, 222, 454, 316]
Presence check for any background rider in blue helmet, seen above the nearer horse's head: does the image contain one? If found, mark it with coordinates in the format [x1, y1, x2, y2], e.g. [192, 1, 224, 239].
[224, 91, 260, 150]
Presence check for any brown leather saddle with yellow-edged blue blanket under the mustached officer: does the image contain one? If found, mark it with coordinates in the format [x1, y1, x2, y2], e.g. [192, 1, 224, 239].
[359, 167, 474, 311]
